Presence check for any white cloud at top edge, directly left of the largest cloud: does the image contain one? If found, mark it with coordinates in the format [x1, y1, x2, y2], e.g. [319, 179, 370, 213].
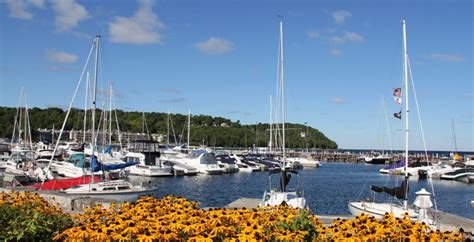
[52, 0, 90, 31]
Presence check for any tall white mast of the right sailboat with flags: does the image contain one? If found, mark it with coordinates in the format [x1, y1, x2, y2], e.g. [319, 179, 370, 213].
[402, 20, 410, 209]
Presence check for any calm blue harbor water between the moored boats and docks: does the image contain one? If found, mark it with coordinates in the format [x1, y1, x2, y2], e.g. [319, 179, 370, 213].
[134, 163, 474, 219]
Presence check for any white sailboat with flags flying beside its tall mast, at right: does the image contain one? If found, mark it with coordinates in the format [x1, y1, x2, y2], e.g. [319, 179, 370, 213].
[348, 20, 436, 224]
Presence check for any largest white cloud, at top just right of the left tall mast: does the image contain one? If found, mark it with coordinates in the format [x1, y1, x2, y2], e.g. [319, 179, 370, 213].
[109, 0, 165, 44]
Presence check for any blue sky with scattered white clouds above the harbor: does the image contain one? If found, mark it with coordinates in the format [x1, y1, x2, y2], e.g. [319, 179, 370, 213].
[0, 0, 474, 151]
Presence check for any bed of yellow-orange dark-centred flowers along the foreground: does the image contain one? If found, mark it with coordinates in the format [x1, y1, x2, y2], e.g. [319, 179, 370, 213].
[54, 196, 463, 241]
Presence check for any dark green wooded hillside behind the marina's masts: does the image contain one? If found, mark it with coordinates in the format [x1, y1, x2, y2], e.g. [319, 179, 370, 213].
[0, 107, 337, 149]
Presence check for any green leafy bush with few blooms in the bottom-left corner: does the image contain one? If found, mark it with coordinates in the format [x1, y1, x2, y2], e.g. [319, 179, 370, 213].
[0, 204, 74, 241]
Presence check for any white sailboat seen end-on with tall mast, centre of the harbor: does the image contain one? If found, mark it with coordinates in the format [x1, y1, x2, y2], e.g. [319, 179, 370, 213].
[260, 19, 306, 208]
